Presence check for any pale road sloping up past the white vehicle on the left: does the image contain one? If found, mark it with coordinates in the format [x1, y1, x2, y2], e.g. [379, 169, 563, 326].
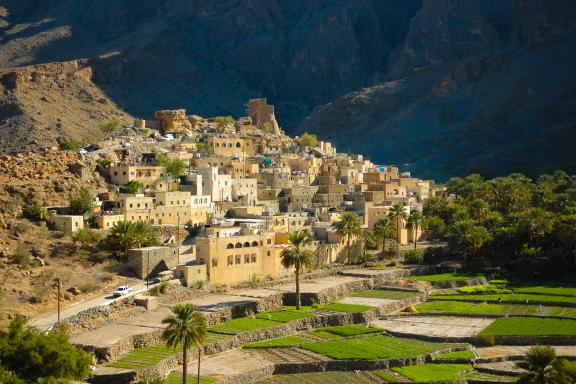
[30, 282, 154, 331]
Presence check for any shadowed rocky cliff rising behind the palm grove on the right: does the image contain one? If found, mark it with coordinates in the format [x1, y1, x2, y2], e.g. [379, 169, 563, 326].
[300, 0, 576, 177]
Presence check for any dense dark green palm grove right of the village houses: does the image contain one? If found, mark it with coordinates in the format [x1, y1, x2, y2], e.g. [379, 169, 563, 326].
[424, 171, 576, 279]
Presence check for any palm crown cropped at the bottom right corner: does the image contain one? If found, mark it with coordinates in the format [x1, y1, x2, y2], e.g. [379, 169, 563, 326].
[516, 345, 574, 384]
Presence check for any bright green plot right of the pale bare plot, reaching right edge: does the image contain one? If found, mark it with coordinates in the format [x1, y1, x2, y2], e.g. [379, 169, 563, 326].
[478, 317, 576, 336]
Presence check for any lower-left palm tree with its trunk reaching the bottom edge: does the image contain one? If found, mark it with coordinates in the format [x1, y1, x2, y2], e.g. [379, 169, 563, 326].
[162, 304, 207, 384]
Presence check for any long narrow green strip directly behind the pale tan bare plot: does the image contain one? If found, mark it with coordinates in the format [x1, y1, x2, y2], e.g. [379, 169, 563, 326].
[416, 300, 576, 318]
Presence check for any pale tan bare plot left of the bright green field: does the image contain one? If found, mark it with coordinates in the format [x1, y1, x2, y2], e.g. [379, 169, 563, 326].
[370, 316, 494, 337]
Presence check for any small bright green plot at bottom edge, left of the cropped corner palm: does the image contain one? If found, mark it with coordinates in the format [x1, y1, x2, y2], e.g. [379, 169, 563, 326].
[392, 364, 472, 383]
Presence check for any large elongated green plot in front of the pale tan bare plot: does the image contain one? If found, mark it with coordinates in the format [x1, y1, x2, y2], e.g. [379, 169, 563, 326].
[302, 336, 447, 360]
